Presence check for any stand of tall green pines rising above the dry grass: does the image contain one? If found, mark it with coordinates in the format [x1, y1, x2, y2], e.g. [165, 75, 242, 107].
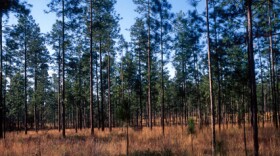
[0, 0, 280, 155]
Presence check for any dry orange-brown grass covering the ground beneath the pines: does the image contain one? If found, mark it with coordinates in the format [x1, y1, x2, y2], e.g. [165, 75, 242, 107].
[0, 124, 280, 156]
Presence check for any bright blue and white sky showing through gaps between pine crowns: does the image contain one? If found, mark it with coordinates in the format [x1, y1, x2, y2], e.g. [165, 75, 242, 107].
[8, 0, 204, 78]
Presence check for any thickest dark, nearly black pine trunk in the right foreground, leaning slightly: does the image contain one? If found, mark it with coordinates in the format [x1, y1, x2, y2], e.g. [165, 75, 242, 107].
[246, 0, 259, 156]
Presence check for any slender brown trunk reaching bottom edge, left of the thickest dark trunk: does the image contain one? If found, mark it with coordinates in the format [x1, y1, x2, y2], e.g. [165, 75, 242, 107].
[206, 0, 216, 155]
